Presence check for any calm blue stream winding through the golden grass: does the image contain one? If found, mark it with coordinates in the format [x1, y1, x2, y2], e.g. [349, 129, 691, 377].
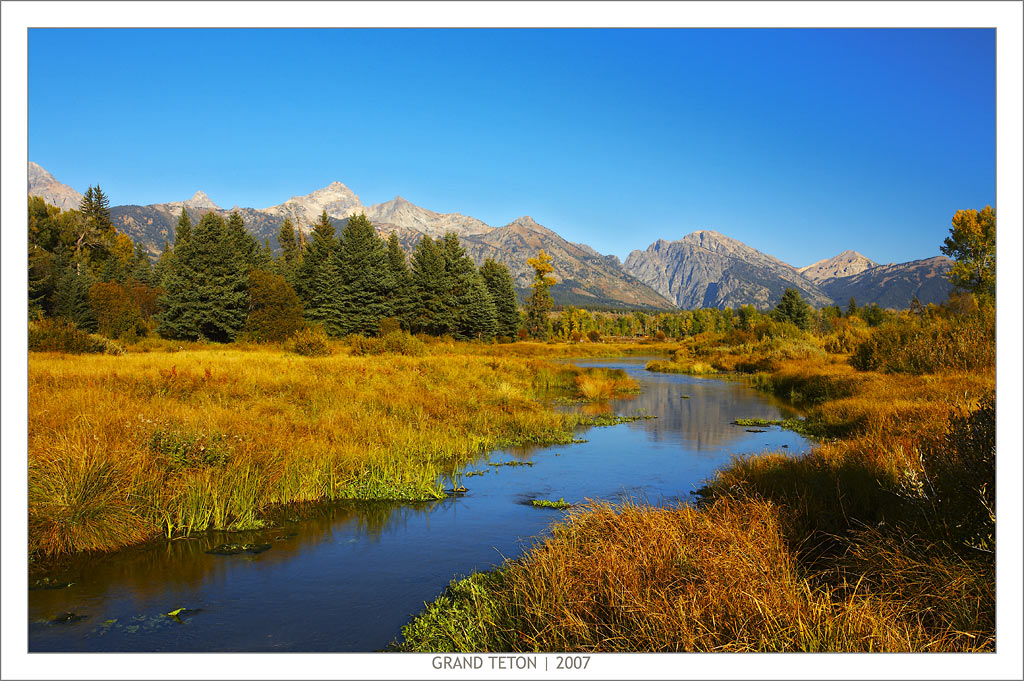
[29, 358, 809, 652]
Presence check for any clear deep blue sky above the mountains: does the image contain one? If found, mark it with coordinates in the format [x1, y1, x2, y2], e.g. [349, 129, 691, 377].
[29, 30, 995, 265]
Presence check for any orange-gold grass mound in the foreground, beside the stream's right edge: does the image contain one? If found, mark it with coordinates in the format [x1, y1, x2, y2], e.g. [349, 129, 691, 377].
[397, 500, 942, 652]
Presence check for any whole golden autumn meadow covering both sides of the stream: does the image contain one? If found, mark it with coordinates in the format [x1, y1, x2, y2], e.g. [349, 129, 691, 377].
[29, 309, 995, 651]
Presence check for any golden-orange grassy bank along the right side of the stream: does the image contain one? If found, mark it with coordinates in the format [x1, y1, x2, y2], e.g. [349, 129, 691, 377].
[395, 321, 995, 651]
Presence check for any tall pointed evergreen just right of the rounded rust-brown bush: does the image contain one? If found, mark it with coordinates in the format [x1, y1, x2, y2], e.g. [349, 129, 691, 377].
[295, 211, 342, 336]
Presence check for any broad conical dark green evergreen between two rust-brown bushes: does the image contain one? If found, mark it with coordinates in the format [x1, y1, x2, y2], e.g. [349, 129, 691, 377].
[157, 213, 249, 342]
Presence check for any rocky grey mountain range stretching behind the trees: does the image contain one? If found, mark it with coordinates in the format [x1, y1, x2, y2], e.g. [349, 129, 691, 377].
[29, 162, 952, 309]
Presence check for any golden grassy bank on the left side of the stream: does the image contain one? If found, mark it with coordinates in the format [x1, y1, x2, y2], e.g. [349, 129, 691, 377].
[29, 341, 635, 560]
